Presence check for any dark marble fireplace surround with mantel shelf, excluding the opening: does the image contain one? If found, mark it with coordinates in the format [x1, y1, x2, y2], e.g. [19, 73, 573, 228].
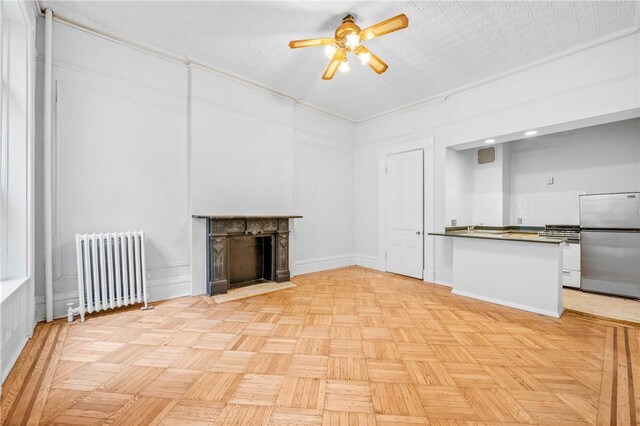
[193, 215, 302, 295]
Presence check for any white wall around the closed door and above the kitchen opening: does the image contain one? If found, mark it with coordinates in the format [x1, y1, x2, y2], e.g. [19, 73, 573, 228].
[354, 33, 640, 283]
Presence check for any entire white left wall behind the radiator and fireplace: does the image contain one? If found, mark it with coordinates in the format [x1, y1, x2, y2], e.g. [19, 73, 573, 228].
[37, 21, 354, 318]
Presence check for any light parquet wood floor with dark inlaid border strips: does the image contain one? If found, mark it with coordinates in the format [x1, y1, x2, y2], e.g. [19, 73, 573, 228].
[1, 267, 640, 425]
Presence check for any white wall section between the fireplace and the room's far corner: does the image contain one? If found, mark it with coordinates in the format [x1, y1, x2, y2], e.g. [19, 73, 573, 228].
[292, 106, 355, 274]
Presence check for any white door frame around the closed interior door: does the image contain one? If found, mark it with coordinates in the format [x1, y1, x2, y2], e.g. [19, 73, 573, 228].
[378, 136, 435, 282]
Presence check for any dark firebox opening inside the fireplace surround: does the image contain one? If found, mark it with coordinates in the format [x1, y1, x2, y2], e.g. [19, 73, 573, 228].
[229, 235, 274, 288]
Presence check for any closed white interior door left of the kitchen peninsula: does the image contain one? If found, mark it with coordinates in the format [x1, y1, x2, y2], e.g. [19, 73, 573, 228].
[385, 150, 424, 279]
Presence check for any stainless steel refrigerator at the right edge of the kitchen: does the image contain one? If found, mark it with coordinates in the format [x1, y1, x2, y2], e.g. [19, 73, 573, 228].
[580, 192, 640, 299]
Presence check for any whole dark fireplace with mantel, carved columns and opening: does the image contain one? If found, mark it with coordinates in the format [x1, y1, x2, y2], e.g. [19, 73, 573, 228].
[194, 216, 302, 295]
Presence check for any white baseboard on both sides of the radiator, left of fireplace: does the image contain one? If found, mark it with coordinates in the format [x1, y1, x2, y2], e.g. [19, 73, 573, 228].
[36, 276, 191, 321]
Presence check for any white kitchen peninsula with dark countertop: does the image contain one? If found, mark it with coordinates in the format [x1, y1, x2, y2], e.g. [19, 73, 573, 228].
[429, 228, 566, 318]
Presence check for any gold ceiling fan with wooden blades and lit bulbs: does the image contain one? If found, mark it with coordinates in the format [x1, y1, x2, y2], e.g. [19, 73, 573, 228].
[289, 14, 409, 80]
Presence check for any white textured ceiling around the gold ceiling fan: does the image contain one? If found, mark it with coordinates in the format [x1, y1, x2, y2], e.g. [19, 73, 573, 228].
[40, 1, 640, 121]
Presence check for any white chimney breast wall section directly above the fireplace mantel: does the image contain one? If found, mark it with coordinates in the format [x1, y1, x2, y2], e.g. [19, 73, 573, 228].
[191, 68, 293, 218]
